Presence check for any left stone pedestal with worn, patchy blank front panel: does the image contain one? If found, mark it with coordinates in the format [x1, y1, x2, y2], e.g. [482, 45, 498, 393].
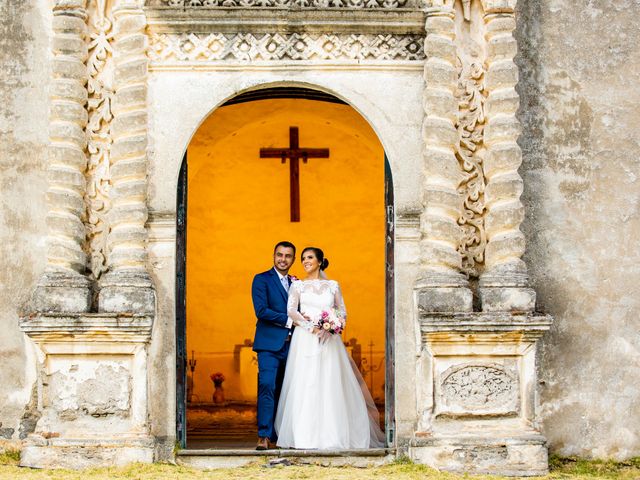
[20, 314, 154, 468]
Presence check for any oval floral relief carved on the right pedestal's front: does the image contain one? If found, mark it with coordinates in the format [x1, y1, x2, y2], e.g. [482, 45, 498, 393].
[441, 364, 519, 410]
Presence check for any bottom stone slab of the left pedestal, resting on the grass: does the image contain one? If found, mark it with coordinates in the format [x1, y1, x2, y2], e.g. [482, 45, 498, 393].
[20, 435, 154, 470]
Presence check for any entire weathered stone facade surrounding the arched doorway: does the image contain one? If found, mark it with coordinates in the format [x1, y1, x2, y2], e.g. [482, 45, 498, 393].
[0, 0, 640, 474]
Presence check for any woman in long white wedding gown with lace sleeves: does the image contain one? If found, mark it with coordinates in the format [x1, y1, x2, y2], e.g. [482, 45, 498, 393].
[275, 247, 384, 449]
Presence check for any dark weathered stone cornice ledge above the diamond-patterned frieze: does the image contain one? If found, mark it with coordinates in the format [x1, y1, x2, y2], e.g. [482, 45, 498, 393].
[145, 7, 425, 35]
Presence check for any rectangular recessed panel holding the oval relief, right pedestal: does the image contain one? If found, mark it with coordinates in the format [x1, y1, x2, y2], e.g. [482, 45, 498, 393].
[436, 360, 520, 416]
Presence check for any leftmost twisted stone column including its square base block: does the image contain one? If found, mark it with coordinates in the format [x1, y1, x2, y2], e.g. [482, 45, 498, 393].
[33, 0, 91, 312]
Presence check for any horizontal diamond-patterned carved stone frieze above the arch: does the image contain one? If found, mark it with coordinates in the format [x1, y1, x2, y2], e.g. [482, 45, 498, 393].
[149, 33, 424, 62]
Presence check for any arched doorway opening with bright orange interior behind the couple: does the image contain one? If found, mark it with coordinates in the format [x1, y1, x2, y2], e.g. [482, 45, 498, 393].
[176, 88, 394, 448]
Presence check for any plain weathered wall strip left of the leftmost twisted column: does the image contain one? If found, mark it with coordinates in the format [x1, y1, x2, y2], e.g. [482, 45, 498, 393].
[0, 0, 51, 439]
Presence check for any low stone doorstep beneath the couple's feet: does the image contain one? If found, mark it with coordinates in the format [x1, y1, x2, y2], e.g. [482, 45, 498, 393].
[176, 448, 396, 469]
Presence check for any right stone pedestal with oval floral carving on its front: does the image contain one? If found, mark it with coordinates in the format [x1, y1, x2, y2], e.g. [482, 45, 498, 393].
[409, 312, 551, 476]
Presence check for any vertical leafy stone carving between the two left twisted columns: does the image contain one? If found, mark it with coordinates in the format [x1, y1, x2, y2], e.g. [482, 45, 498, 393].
[85, 0, 113, 279]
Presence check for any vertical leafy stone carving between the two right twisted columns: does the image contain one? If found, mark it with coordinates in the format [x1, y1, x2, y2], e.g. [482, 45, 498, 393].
[456, 58, 487, 276]
